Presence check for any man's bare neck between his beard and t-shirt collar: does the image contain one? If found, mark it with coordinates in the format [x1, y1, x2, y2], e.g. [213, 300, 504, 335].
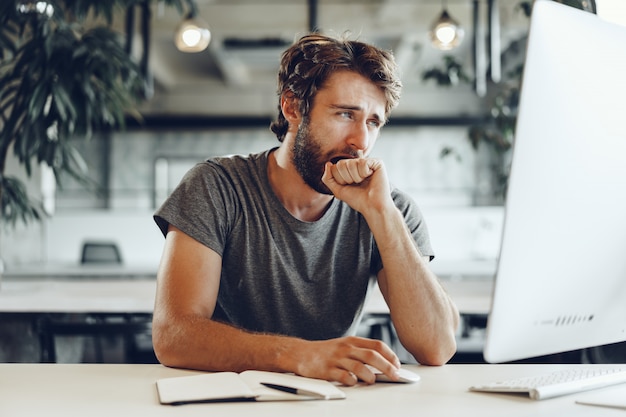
[267, 145, 333, 222]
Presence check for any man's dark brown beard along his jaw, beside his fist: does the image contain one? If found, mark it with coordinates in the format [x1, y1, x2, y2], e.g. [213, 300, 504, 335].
[292, 117, 332, 195]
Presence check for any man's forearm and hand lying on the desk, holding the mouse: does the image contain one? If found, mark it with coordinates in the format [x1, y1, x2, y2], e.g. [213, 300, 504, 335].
[153, 317, 400, 385]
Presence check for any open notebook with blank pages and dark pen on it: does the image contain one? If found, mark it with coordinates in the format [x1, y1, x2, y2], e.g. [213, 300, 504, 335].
[156, 371, 346, 405]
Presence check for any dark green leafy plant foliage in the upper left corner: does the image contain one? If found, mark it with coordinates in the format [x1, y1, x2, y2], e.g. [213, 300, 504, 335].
[0, 0, 193, 225]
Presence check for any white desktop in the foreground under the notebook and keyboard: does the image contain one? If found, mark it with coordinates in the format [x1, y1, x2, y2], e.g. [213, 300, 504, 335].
[0, 364, 626, 417]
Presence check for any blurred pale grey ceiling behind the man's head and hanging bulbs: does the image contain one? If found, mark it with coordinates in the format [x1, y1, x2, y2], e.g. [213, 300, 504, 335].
[124, 0, 528, 117]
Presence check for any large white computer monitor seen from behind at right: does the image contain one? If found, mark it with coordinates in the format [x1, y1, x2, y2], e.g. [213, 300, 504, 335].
[484, 0, 626, 363]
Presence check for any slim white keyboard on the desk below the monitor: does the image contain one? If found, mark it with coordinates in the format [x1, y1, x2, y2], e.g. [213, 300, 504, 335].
[470, 368, 626, 400]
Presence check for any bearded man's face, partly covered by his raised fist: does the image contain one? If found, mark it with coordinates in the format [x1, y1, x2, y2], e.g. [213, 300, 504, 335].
[292, 71, 385, 194]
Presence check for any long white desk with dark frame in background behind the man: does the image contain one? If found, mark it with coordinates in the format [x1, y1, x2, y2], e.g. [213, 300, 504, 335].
[0, 269, 493, 361]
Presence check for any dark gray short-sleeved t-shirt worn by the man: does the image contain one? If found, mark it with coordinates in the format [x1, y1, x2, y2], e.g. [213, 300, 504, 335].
[154, 151, 432, 340]
